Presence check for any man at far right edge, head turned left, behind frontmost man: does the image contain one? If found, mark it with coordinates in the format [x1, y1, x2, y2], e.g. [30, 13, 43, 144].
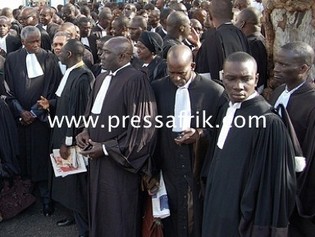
[271, 42, 315, 237]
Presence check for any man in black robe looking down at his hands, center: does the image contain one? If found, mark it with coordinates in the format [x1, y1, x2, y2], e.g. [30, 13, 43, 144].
[152, 45, 226, 237]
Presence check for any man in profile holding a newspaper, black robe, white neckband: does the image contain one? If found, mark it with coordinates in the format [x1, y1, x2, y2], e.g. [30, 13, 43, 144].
[41, 39, 94, 236]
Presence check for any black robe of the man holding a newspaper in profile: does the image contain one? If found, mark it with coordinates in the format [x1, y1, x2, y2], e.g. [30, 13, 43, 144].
[50, 66, 94, 215]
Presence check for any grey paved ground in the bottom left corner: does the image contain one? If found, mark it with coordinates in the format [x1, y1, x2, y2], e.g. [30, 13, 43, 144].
[0, 199, 78, 237]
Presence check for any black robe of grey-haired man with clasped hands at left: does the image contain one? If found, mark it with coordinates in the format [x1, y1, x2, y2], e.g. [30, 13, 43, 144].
[5, 48, 62, 181]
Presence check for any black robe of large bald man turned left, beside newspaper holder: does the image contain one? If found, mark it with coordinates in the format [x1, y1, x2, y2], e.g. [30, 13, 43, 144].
[87, 66, 156, 237]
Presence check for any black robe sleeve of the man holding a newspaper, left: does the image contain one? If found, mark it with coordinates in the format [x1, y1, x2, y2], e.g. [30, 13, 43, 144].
[65, 74, 94, 146]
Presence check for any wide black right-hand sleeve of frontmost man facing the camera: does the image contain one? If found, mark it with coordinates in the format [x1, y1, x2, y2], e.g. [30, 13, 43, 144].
[239, 113, 296, 237]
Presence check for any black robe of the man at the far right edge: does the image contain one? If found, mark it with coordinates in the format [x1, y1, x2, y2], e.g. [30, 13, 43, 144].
[270, 82, 315, 236]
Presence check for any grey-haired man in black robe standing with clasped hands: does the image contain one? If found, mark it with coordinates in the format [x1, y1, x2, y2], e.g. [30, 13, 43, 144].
[5, 26, 61, 216]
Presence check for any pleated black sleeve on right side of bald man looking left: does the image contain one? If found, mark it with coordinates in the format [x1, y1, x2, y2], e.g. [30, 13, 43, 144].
[103, 72, 157, 175]
